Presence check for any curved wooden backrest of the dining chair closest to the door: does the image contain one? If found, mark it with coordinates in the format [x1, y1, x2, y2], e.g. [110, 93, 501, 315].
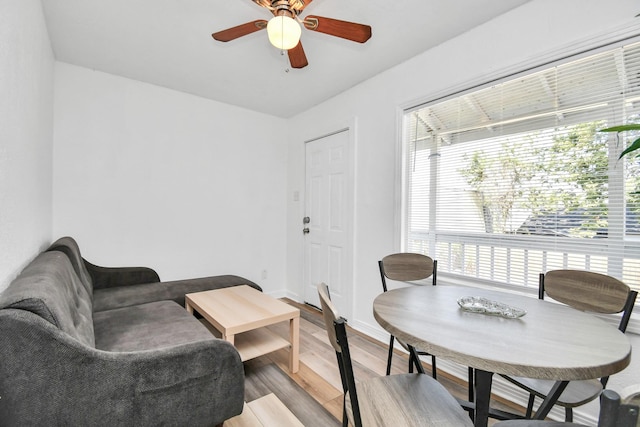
[378, 252, 438, 292]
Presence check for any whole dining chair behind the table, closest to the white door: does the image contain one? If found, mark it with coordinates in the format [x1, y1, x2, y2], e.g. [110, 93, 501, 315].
[378, 252, 438, 378]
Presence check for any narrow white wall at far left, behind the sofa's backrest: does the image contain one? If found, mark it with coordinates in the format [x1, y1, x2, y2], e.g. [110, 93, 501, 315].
[0, 0, 54, 290]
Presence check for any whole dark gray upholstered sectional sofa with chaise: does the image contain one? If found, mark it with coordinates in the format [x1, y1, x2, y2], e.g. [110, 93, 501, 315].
[0, 237, 260, 426]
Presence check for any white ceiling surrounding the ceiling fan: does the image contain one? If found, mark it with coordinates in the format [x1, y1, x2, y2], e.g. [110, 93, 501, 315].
[42, 0, 528, 117]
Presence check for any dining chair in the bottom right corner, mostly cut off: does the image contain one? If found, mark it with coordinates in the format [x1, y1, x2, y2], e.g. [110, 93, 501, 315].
[494, 390, 639, 427]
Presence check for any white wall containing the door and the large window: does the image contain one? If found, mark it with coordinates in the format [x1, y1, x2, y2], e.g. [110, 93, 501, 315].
[287, 0, 640, 422]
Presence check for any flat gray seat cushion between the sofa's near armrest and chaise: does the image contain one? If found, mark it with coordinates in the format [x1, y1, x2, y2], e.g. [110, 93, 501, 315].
[93, 301, 214, 351]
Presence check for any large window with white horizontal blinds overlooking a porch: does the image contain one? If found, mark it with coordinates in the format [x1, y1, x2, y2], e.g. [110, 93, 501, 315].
[402, 43, 640, 300]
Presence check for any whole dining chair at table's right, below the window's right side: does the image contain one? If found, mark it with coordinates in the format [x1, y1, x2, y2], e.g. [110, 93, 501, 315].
[502, 270, 638, 422]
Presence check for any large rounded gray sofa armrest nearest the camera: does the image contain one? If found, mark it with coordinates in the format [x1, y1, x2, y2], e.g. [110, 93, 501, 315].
[0, 309, 244, 426]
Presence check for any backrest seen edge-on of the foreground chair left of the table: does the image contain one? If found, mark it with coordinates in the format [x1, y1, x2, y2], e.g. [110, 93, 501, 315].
[318, 283, 362, 427]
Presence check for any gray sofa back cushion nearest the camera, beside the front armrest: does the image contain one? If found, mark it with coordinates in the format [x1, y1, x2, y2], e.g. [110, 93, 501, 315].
[0, 251, 95, 347]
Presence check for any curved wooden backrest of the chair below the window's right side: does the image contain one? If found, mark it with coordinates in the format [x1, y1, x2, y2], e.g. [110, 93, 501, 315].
[538, 270, 638, 332]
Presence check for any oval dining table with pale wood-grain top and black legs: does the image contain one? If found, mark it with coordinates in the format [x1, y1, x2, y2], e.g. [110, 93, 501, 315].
[373, 285, 631, 427]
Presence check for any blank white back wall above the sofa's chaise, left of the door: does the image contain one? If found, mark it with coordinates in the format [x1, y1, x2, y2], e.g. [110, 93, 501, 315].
[53, 63, 287, 294]
